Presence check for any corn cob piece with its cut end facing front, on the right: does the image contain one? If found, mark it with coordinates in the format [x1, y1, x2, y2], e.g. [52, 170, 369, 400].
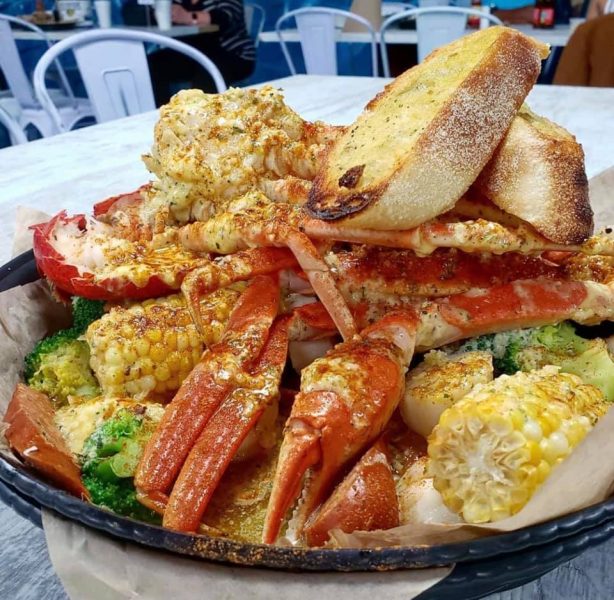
[428, 367, 608, 523]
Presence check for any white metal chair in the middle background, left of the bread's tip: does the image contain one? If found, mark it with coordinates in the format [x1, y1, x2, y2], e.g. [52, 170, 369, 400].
[275, 6, 378, 77]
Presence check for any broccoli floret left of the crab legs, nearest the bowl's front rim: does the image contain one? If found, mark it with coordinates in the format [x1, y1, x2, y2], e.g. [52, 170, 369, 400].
[81, 409, 160, 524]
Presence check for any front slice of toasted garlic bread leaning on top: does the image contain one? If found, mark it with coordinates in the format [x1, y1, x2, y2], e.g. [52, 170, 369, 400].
[307, 27, 547, 230]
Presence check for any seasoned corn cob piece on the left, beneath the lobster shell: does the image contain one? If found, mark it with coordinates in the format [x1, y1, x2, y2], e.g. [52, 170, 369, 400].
[85, 289, 239, 400]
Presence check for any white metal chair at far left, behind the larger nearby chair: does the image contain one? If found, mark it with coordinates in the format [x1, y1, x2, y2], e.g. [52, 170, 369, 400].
[0, 14, 94, 137]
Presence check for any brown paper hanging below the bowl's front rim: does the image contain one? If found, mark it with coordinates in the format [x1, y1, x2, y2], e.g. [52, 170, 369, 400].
[43, 511, 452, 600]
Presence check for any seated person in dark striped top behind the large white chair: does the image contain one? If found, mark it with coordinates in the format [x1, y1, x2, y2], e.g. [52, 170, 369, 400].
[123, 0, 256, 106]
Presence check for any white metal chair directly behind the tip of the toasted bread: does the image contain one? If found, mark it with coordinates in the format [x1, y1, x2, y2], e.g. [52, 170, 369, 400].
[380, 6, 503, 77]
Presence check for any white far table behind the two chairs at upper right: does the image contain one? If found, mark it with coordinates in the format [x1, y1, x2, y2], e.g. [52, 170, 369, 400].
[259, 25, 572, 46]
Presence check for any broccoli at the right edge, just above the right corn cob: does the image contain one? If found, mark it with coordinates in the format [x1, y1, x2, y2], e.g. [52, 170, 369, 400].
[459, 322, 614, 402]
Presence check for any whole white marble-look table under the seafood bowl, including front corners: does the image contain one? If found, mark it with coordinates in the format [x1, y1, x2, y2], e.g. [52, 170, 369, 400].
[0, 76, 614, 600]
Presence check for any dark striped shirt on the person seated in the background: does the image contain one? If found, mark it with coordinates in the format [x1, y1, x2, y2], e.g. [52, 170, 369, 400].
[178, 0, 256, 60]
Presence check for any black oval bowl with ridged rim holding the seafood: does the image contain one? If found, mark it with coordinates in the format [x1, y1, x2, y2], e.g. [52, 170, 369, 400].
[0, 252, 614, 598]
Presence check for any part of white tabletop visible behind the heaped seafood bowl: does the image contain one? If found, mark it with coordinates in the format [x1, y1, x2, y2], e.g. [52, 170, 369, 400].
[0, 75, 614, 262]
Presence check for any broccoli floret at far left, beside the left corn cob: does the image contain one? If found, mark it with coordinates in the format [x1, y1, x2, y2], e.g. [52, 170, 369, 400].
[24, 297, 104, 405]
